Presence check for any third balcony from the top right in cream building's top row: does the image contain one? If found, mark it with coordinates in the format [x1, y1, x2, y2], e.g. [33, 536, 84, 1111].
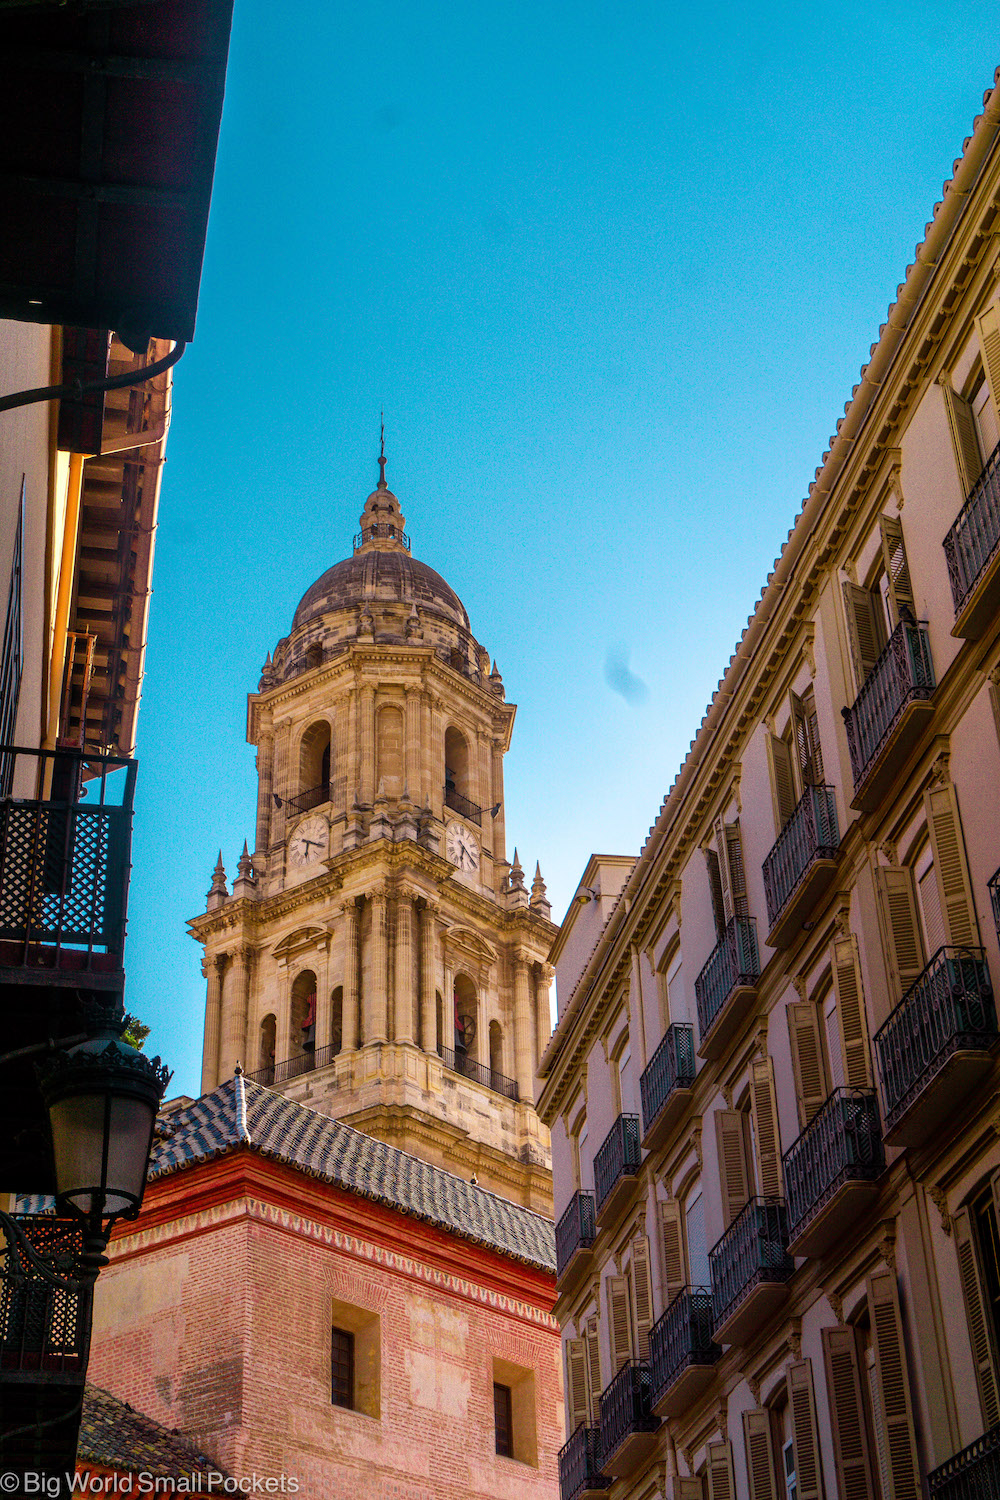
[763, 786, 840, 948]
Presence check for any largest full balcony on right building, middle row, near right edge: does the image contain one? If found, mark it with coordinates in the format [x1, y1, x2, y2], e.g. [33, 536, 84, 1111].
[876, 948, 997, 1146]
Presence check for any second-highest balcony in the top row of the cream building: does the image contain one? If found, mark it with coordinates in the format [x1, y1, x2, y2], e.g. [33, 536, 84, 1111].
[843, 621, 934, 813]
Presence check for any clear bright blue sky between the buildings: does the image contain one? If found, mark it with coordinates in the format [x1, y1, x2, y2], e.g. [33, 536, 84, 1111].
[126, 0, 1000, 1094]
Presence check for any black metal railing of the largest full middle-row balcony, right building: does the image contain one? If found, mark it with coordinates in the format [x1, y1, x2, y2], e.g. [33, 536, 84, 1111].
[876, 948, 997, 1130]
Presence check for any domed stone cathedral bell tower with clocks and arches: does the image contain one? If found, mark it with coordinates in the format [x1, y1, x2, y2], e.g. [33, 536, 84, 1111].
[190, 456, 556, 1214]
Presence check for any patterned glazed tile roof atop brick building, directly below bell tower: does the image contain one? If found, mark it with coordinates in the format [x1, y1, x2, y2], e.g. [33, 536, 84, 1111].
[150, 1074, 556, 1274]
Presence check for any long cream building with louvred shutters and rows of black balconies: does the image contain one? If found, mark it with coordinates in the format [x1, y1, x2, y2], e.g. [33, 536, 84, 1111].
[538, 79, 1000, 1500]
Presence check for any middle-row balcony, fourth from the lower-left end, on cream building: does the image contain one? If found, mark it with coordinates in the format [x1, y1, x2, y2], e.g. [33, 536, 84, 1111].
[708, 1199, 795, 1344]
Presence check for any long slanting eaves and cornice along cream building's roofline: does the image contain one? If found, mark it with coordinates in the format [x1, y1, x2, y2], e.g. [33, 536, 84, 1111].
[538, 68, 1000, 1127]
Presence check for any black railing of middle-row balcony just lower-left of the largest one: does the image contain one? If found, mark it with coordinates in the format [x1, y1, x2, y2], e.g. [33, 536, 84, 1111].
[783, 1089, 886, 1239]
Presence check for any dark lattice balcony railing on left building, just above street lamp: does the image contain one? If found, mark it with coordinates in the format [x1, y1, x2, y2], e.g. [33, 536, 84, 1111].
[0, 746, 136, 971]
